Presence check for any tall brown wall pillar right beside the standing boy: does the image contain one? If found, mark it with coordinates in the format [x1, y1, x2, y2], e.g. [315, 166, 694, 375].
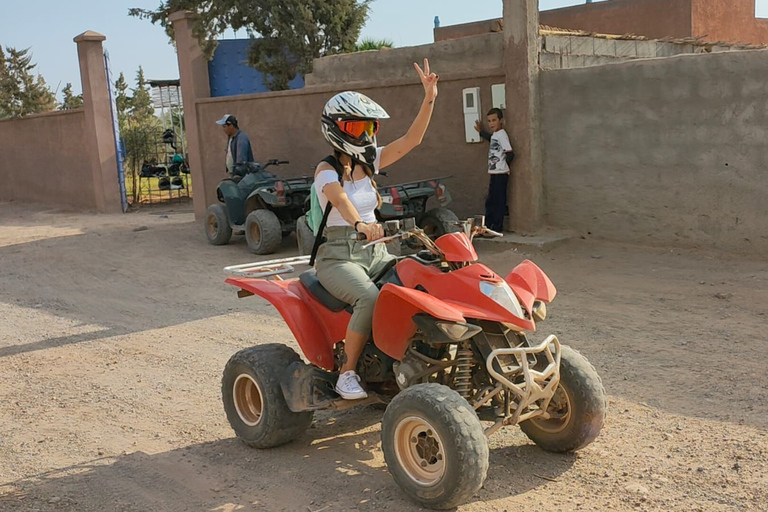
[504, 0, 544, 233]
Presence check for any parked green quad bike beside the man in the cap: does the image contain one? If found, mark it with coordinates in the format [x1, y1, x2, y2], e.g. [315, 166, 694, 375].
[205, 160, 312, 254]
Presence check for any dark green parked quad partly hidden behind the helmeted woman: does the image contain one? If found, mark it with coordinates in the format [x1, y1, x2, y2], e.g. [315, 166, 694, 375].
[296, 176, 459, 255]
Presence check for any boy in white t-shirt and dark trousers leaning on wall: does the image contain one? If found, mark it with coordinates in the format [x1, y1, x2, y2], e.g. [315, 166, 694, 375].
[475, 108, 515, 232]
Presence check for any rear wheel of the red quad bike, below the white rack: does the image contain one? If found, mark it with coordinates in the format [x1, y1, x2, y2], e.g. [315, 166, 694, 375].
[221, 344, 312, 448]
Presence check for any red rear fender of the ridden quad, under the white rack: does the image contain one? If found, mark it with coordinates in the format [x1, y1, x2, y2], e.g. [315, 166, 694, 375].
[220, 277, 334, 371]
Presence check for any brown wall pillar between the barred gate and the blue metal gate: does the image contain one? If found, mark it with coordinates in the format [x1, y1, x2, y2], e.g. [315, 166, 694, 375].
[169, 11, 212, 220]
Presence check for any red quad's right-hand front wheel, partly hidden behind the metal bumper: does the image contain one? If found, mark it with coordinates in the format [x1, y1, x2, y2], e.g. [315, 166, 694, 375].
[520, 345, 607, 452]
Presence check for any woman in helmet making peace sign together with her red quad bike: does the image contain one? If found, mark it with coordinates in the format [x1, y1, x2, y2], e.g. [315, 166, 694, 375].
[222, 61, 606, 509]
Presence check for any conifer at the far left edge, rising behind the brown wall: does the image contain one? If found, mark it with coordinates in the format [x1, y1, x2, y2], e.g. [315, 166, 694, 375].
[0, 47, 56, 117]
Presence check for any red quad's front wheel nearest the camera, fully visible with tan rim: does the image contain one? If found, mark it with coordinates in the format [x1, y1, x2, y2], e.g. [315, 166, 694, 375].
[381, 384, 488, 509]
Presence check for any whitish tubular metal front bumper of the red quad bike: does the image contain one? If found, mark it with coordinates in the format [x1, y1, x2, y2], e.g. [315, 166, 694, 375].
[484, 334, 561, 436]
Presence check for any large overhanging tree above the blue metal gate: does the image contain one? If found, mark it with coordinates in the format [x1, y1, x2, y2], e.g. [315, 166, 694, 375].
[129, 0, 372, 90]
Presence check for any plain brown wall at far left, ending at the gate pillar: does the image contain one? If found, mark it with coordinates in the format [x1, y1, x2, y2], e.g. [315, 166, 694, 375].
[0, 109, 96, 210]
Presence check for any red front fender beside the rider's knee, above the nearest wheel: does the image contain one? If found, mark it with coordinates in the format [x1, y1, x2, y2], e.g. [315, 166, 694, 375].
[373, 283, 466, 361]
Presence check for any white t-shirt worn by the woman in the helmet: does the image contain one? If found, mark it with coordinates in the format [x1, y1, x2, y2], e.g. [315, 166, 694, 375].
[314, 147, 384, 226]
